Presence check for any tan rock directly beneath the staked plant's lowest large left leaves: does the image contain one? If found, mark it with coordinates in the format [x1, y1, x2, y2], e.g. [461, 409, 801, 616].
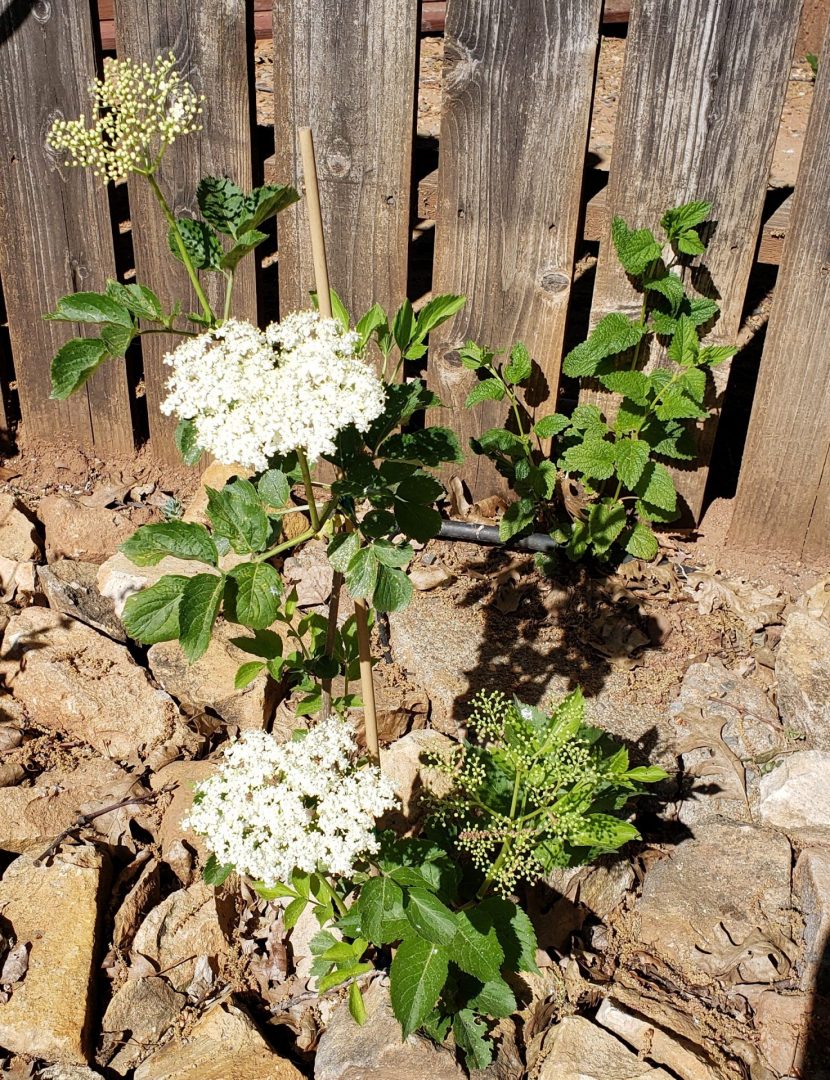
[147, 620, 277, 731]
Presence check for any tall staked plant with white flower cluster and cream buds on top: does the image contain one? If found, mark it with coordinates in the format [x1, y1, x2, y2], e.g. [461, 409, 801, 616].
[46, 55, 464, 714]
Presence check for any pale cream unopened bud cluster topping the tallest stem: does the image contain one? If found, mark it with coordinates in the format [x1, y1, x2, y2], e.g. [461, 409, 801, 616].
[47, 53, 204, 183]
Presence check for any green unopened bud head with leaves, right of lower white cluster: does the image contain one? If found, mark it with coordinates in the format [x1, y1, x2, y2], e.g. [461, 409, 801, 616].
[423, 690, 666, 896]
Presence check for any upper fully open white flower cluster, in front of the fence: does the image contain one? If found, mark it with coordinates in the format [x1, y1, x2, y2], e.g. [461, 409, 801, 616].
[161, 311, 385, 471]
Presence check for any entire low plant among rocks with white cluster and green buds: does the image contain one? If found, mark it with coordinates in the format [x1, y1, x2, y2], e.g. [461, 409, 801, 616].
[190, 692, 665, 1068]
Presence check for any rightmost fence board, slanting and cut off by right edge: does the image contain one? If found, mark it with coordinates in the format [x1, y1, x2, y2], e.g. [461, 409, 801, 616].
[729, 16, 830, 564]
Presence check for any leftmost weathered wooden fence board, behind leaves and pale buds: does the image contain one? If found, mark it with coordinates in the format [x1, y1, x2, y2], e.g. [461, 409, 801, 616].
[0, 0, 133, 453]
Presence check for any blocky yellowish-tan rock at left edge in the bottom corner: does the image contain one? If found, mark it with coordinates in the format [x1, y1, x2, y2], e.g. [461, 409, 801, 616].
[0, 848, 108, 1065]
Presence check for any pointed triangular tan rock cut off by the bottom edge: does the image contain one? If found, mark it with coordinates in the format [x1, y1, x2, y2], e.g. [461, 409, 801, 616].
[135, 1005, 302, 1080]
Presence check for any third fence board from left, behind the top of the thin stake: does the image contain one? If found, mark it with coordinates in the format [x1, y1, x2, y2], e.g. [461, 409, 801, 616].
[274, 0, 418, 319]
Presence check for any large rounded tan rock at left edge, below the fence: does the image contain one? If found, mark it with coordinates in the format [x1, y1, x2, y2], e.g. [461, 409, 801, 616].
[0, 608, 183, 761]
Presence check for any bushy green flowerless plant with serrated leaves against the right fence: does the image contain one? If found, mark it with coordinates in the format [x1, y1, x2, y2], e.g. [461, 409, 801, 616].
[461, 202, 736, 559]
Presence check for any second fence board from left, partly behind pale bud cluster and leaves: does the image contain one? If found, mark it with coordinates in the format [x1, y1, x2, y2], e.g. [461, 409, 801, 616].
[115, 0, 257, 461]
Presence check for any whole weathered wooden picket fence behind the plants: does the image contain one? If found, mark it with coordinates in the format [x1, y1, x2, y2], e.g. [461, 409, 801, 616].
[0, 0, 830, 557]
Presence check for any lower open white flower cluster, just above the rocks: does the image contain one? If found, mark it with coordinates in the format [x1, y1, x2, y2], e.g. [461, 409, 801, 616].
[185, 717, 397, 886]
